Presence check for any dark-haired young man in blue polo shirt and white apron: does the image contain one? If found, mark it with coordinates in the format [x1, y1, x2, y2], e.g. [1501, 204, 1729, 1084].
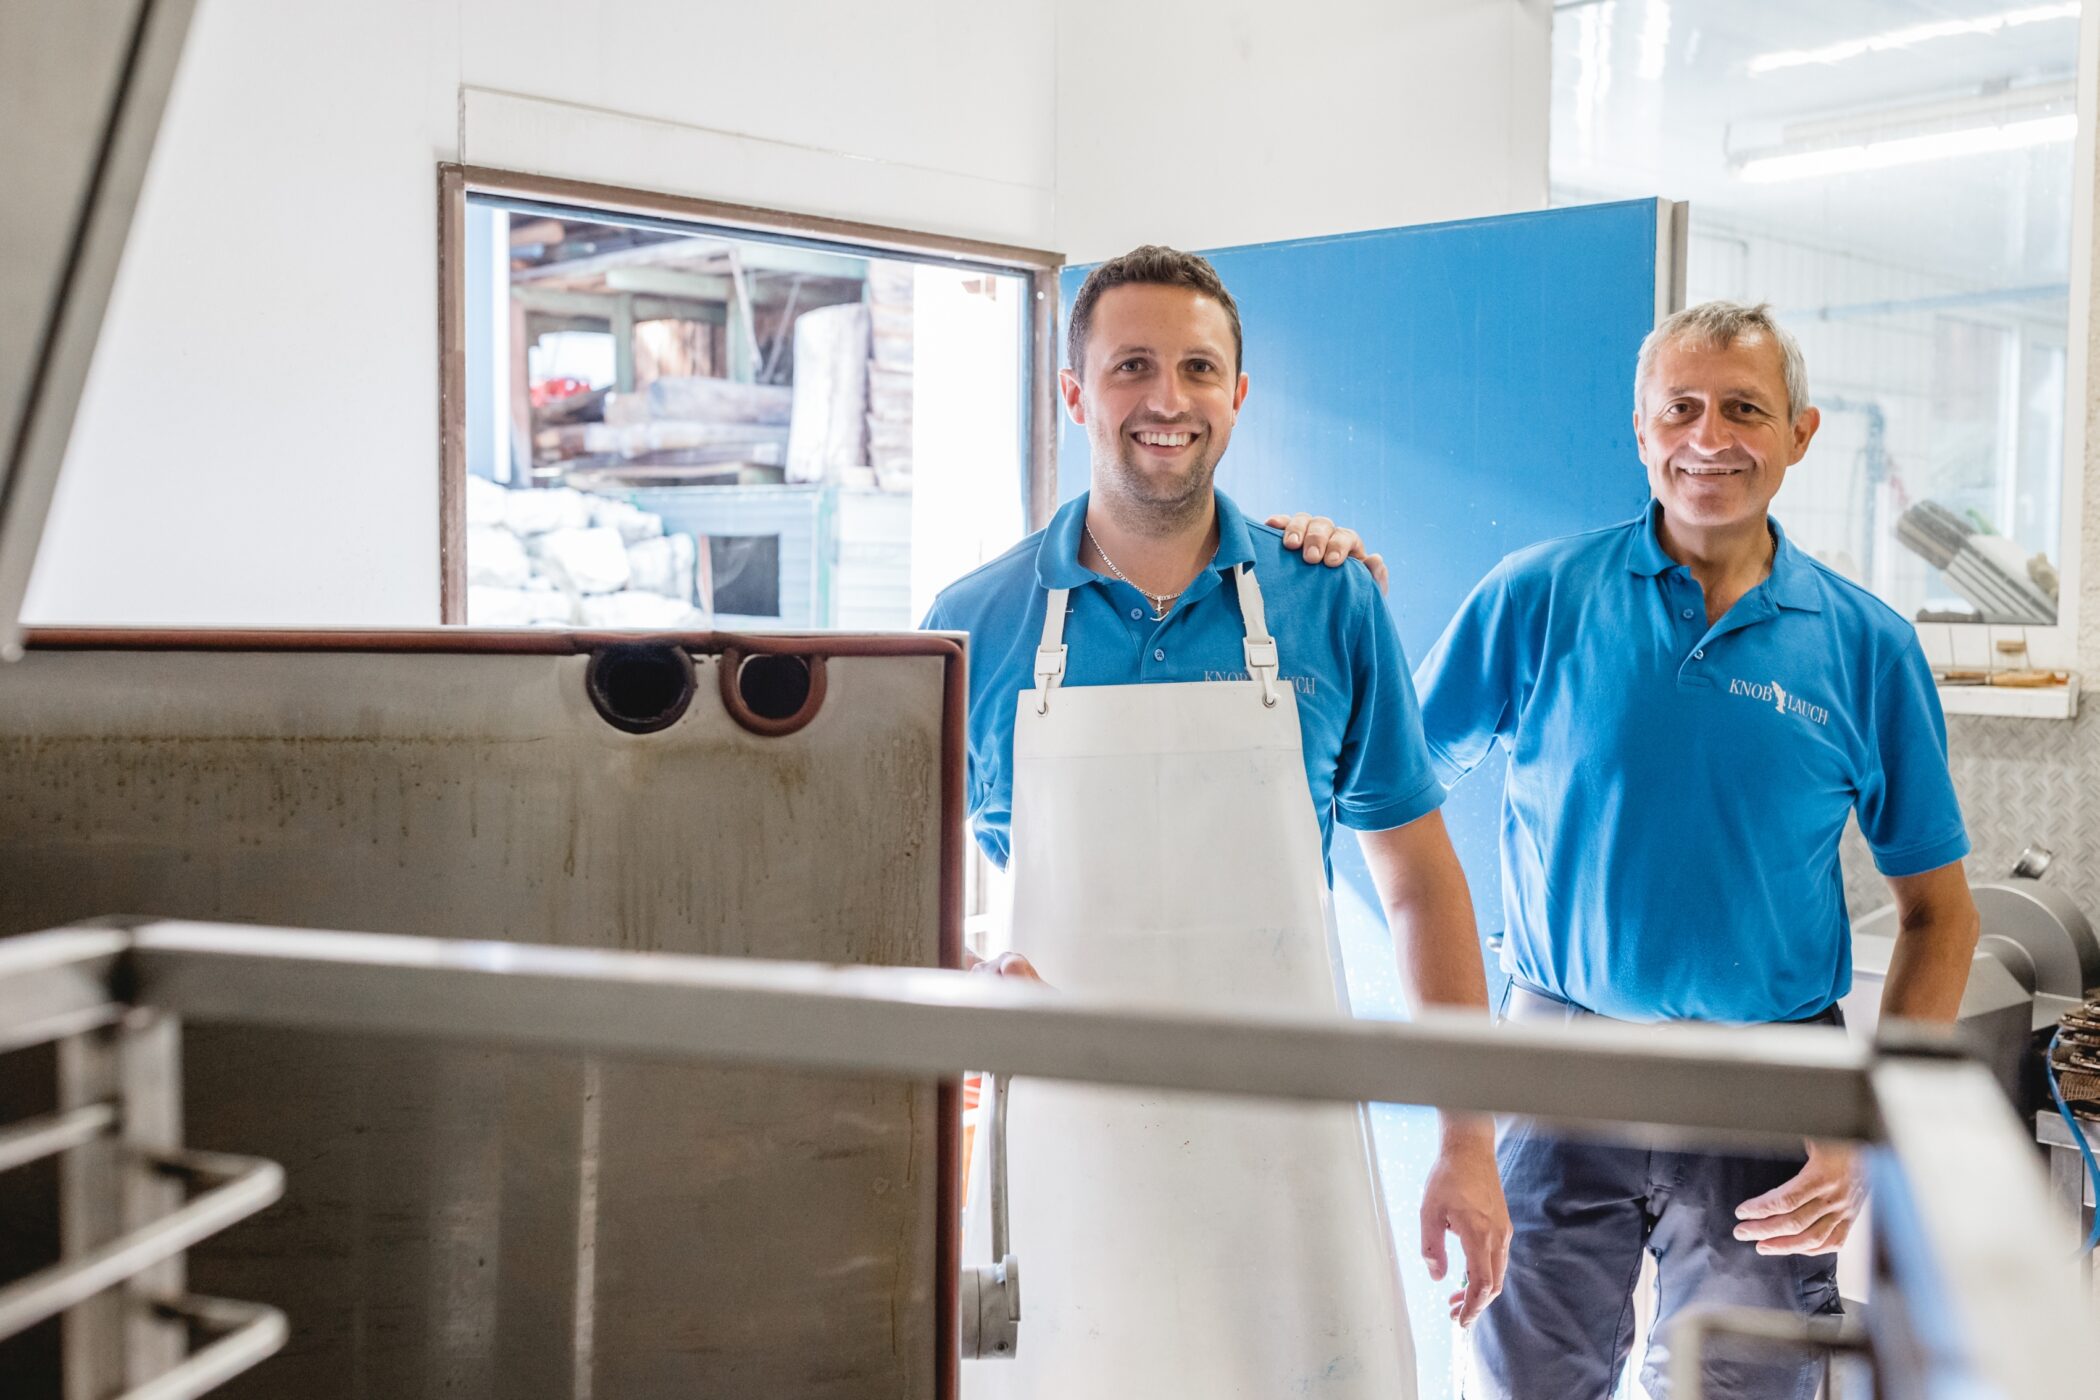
[926, 248, 1508, 1400]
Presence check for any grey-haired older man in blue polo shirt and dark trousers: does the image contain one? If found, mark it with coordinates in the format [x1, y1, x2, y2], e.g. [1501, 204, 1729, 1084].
[1415, 302, 1976, 1400]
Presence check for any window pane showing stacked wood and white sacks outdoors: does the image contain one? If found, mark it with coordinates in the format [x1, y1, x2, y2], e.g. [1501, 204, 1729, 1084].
[464, 195, 1033, 630]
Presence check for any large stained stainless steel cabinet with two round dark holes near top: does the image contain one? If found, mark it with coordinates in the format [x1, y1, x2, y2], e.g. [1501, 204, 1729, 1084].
[0, 632, 964, 1400]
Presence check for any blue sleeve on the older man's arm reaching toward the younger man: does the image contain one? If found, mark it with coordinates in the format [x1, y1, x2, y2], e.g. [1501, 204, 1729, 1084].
[1415, 560, 1520, 787]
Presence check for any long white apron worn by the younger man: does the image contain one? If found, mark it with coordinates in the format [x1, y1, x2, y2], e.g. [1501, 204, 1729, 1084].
[962, 565, 1415, 1400]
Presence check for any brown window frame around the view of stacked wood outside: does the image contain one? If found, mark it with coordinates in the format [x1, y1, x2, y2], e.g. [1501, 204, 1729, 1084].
[437, 162, 1065, 623]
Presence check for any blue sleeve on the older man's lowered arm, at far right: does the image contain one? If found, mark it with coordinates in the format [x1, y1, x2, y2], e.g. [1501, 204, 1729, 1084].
[1856, 636, 1970, 877]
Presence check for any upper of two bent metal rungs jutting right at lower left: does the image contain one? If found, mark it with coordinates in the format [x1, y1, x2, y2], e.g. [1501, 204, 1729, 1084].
[0, 1152, 284, 1339]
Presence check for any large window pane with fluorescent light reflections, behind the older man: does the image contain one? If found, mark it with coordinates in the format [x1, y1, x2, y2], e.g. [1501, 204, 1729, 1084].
[1552, 0, 2079, 623]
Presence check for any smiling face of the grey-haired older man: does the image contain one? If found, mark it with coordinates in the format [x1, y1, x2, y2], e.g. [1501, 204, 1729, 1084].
[1634, 332, 1819, 529]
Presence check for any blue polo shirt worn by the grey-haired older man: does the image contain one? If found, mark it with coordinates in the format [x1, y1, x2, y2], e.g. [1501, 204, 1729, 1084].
[1415, 502, 1970, 1022]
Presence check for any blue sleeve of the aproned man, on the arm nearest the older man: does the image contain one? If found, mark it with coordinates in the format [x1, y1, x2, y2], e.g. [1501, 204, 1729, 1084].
[1334, 575, 1443, 831]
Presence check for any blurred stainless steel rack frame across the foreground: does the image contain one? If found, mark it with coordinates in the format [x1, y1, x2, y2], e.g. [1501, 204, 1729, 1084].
[0, 924, 2100, 1400]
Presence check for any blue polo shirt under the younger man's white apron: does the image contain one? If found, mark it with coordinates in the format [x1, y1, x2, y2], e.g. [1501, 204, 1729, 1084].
[920, 491, 1443, 875]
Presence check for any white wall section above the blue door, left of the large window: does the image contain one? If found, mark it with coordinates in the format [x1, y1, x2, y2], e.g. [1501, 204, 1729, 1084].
[1056, 0, 1552, 262]
